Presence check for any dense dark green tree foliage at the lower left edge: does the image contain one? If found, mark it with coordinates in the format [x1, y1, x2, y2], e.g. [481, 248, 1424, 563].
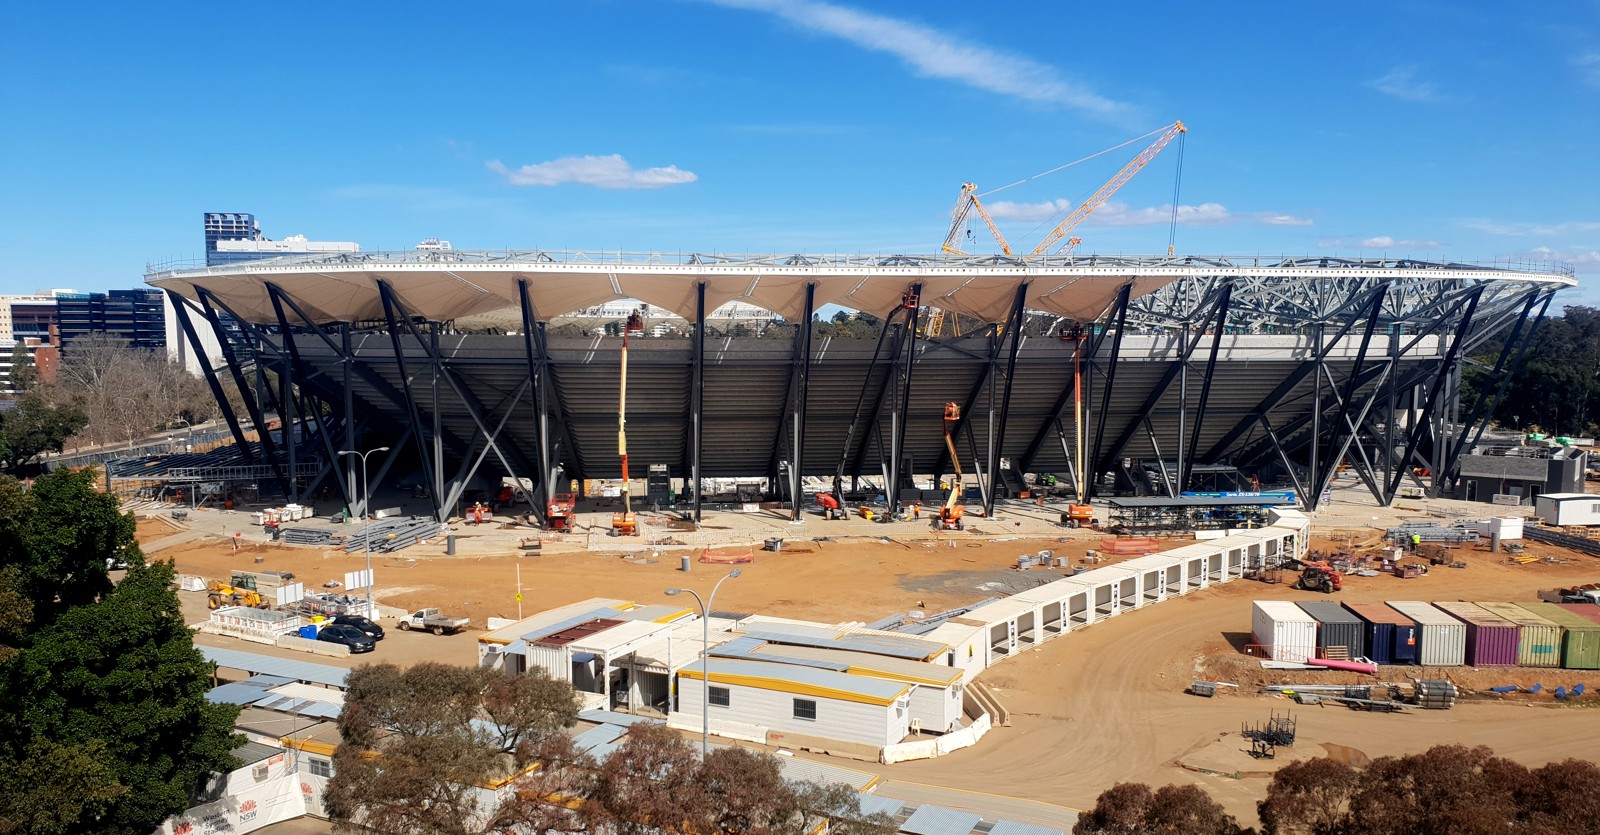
[0, 470, 238, 835]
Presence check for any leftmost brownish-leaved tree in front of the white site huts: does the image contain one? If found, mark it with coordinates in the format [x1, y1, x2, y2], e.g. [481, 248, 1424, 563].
[323, 662, 578, 835]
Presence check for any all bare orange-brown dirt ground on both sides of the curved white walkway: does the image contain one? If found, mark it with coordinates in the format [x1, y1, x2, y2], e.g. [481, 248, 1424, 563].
[152, 520, 1600, 821]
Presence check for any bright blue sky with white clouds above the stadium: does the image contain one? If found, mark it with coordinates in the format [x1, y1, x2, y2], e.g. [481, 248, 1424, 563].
[0, 0, 1600, 302]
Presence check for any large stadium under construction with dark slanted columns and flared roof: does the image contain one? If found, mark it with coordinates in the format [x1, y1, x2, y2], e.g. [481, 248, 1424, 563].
[146, 250, 1576, 518]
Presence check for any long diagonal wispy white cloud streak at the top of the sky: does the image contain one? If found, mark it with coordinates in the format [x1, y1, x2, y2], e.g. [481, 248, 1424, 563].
[709, 0, 1128, 115]
